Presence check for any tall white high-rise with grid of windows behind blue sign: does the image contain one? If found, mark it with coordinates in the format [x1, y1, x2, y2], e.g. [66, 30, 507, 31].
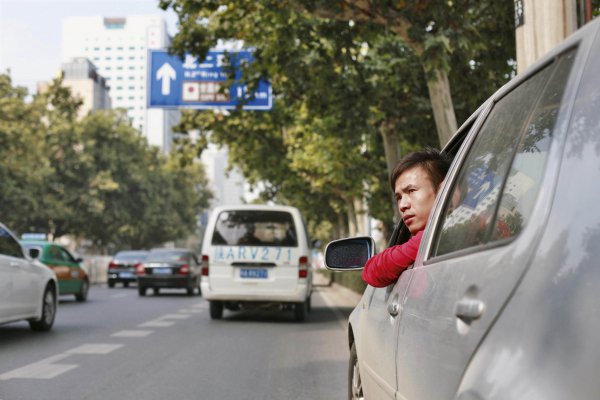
[62, 15, 179, 151]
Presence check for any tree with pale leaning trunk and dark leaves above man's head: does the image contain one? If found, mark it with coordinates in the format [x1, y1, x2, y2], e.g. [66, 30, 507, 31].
[292, 0, 514, 146]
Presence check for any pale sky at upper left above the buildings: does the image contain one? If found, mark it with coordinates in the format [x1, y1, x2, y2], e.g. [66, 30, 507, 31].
[0, 0, 177, 94]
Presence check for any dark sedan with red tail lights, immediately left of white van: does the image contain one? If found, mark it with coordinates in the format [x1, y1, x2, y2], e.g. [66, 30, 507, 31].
[136, 249, 201, 296]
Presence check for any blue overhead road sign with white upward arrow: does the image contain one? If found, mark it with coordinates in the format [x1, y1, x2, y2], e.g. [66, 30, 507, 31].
[148, 50, 273, 110]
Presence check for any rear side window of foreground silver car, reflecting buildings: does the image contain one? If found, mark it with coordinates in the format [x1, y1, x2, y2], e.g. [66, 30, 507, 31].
[432, 51, 574, 256]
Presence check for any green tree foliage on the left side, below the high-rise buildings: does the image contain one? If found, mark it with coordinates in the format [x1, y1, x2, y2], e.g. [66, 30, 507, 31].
[0, 75, 211, 248]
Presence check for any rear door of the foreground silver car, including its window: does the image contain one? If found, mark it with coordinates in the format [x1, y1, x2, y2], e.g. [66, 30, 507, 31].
[396, 50, 576, 400]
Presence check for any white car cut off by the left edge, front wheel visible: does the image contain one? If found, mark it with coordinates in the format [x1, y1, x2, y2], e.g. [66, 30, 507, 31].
[0, 224, 58, 331]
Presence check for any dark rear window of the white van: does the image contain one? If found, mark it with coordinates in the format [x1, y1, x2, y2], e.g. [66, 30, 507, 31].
[211, 210, 298, 247]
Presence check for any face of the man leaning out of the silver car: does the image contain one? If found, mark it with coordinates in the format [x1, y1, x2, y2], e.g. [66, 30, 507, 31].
[394, 166, 437, 235]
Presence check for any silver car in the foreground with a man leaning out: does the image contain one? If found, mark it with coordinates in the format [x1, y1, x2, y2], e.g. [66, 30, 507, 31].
[325, 15, 600, 400]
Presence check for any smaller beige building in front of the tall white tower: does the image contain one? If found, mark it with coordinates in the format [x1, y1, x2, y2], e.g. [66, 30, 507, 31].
[61, 57, 111, 118]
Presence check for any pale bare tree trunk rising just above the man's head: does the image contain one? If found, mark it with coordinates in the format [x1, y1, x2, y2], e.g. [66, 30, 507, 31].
[427, 69, 458, 147]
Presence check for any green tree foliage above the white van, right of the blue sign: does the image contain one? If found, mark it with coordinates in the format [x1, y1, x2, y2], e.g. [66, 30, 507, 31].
[161, 0, 436, 240]
